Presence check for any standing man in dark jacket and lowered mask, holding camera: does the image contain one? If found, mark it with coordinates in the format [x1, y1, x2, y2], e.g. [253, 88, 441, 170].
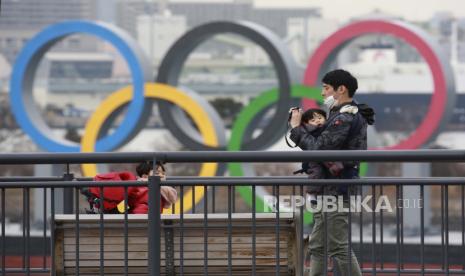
[290, 69, 374, 276]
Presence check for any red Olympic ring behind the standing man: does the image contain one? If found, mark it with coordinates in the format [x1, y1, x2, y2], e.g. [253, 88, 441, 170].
[303, 20, 455, 150]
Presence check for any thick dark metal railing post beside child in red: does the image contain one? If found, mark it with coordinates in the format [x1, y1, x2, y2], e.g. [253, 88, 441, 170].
[148, 176, 161, 276]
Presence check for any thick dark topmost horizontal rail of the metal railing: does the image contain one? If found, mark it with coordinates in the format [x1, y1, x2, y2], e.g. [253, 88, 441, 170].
[0, 150, 465, 165]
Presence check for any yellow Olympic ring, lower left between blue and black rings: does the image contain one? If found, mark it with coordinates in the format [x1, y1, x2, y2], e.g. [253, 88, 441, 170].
[81, 83, 218, 214]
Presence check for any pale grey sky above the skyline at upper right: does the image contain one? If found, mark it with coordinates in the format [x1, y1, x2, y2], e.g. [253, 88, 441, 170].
[255, 0, 465, 22]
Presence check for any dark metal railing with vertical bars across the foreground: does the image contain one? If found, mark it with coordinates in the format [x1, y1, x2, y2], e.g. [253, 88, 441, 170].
[0, 150, 465, 275]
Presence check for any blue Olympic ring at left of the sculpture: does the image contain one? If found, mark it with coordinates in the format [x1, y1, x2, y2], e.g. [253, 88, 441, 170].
[10, 20, 151, 152]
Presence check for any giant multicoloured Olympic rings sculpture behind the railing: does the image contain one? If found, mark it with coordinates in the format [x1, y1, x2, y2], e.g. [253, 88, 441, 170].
[10, 20, 456, 216]
